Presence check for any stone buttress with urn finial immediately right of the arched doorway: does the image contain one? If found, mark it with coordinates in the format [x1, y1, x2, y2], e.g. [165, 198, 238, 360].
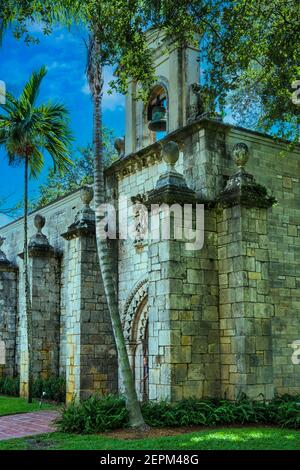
[148, 142, 220, 401]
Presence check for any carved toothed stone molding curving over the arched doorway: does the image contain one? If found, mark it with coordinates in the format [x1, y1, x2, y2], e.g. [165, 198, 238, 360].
[122, 277, 148, 343]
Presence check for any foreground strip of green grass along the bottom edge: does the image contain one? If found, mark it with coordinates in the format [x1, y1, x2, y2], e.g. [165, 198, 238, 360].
[0, 427, 300, 450]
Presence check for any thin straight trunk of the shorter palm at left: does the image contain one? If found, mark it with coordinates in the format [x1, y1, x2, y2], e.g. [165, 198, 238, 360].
[23, 154, 32, 403]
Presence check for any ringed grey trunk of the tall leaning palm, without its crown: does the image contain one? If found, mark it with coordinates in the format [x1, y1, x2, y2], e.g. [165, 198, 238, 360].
[93, 41, 147, 429]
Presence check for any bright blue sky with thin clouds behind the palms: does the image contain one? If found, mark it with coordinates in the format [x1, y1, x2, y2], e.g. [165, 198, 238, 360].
[0, 25, 125, 226]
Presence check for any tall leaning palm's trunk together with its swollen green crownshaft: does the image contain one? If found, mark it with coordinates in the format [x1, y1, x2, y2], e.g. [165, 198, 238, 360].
[86, 33, 147, 430]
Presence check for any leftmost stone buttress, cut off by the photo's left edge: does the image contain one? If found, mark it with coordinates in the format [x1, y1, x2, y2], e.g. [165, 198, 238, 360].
[0, 237, 18, 377]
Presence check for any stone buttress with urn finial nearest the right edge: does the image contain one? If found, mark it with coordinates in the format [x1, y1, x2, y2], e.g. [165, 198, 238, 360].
[218, 143, 274, 399]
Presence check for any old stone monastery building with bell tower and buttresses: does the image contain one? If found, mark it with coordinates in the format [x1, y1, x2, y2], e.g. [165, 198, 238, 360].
[0, 32, 300, 401]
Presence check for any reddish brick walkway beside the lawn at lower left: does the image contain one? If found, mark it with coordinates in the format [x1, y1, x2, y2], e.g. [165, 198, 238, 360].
[0, 411, 59, 441]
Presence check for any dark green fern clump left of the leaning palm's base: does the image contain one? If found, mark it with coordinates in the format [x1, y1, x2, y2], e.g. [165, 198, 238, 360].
[58, 395, 128, 434]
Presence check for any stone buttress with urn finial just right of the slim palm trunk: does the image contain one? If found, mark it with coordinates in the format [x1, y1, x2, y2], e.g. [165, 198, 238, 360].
[20, 214, 60, 396]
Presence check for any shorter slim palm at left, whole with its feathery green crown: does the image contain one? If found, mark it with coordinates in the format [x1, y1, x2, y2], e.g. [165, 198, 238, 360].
[0, 66, 72, 403]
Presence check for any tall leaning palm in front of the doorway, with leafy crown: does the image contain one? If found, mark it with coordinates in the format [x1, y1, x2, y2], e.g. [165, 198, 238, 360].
[0, 1, 147, 429]
